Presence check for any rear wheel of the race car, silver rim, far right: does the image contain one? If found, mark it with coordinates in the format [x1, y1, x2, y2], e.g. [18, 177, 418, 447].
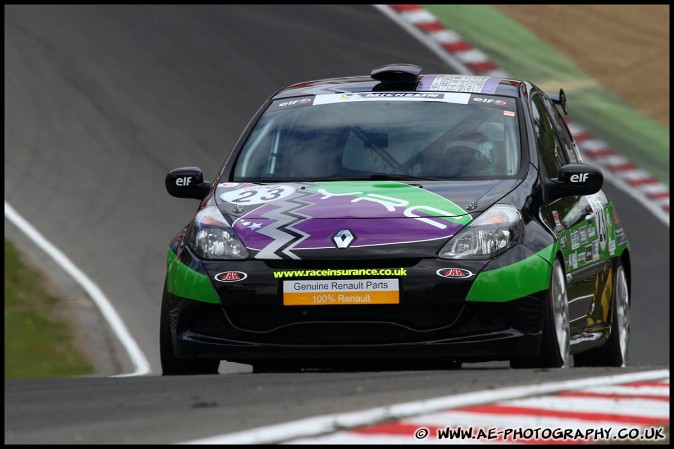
[573, 261, 630, 367]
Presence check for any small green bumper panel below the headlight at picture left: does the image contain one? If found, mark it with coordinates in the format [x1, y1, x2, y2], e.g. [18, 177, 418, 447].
[166, 249, 220, 304]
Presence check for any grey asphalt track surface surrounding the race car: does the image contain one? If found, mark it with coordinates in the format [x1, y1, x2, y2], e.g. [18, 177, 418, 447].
[5, 5, 669, 443]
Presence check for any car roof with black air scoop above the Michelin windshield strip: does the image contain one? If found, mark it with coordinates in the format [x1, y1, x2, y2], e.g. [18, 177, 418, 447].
[272, 64, 528, 99]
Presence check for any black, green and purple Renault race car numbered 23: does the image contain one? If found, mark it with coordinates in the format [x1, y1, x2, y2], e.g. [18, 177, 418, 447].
[160, 63, 631, 375]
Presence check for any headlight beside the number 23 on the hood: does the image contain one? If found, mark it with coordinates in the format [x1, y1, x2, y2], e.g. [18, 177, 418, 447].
[187, 206, 248, 259]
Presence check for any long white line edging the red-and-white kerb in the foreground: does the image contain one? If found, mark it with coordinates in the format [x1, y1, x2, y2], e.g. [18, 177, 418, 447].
[179, 369, 669, 444]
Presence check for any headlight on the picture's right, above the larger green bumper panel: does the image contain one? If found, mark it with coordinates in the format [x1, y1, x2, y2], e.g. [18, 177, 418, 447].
[438, 204, 524, 259]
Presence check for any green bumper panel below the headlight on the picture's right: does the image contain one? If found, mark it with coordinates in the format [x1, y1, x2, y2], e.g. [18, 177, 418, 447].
[466, 244, 557, 302]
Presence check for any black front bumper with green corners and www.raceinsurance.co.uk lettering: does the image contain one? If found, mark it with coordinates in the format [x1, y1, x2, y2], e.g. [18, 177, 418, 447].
[167, 240, 547, 363]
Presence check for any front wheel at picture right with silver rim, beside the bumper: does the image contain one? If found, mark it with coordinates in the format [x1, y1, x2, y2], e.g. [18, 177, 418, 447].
[510, 259, 571, 368]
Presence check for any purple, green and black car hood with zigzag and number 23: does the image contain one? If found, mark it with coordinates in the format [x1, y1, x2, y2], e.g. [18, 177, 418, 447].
[215, 180, 519, 259]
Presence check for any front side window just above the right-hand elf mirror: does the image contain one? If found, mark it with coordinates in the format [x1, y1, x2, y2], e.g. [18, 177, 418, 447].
[531, 94, 567, 178]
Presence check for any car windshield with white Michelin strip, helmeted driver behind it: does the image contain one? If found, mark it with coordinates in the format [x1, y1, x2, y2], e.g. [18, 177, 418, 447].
[232, 93, 521, 182]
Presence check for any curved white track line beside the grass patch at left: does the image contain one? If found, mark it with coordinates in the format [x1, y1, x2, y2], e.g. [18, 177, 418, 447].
[5, 200, 151, 377]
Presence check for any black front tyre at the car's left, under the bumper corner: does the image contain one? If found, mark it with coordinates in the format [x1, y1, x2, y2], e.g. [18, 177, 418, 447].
[159, 282, 220, 376]
